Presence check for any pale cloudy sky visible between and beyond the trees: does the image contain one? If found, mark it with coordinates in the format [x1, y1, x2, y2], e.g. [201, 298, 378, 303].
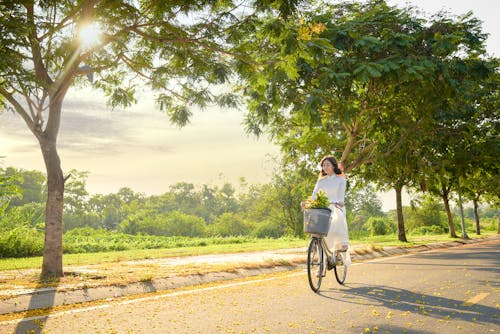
[0, 0, 500, 210]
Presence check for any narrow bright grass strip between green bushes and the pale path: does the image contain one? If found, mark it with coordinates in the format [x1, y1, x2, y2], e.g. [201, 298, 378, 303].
[0, 232, 496, 271]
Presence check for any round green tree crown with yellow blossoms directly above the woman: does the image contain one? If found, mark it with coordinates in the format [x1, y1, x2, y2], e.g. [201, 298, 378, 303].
[238, 1, 446, 167]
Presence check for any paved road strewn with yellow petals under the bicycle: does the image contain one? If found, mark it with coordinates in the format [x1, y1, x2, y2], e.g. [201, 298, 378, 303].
[0, 240, 500, 334]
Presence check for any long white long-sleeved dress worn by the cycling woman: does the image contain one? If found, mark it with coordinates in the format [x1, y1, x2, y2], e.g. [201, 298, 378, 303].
[312, 174, 351, 264]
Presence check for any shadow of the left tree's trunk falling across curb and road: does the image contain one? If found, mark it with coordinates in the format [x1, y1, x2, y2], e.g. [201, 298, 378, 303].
[14, 278, 59, 334]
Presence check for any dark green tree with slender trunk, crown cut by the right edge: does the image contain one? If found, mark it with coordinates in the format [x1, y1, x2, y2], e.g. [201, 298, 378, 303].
[420, 58, 500, 238]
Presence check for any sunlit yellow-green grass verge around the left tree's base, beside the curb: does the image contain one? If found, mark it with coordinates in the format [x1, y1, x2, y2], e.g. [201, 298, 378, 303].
[0, 232, 496, 294]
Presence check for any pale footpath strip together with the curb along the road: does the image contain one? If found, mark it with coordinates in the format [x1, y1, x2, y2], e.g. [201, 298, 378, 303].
[0, 236, 500, 315]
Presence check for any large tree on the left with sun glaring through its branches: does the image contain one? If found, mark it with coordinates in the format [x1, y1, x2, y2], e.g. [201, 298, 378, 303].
[0, 0, 295, 277]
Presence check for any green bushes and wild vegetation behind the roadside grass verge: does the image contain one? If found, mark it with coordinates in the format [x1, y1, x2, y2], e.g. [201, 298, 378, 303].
[0, 167, 500, 270]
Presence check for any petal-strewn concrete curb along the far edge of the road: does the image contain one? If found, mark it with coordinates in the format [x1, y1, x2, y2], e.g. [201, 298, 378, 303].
[0, 236, 500, 315]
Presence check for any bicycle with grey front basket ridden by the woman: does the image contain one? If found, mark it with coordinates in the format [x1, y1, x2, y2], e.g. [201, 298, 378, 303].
[304, 204, 347, 292]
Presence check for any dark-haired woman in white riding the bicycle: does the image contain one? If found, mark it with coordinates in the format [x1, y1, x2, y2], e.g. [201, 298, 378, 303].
[312, 156, 351, 264]
